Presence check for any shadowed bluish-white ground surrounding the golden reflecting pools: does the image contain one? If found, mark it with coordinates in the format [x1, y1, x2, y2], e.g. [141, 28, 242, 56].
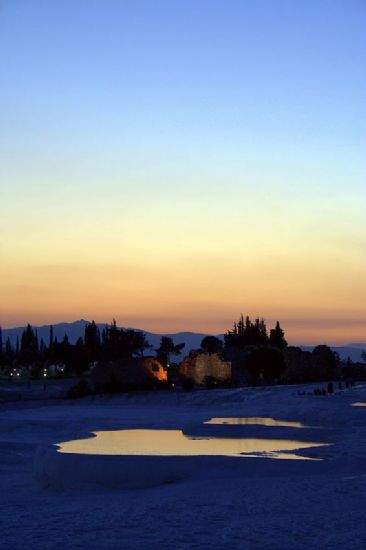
[0, 385, 366, 550]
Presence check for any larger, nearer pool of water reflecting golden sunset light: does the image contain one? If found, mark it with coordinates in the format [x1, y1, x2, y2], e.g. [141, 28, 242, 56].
[58, 430, 327, 460]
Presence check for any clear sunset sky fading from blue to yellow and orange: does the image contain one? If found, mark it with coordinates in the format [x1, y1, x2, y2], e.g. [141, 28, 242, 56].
[0, 0, 366, 344]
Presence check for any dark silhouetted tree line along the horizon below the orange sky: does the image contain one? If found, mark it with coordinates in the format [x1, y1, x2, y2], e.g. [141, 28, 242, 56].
[0, 315, 358, 385]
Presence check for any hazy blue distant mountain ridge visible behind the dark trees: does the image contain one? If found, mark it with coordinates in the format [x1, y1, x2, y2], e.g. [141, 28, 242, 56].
[3, 319, 366, 361]
